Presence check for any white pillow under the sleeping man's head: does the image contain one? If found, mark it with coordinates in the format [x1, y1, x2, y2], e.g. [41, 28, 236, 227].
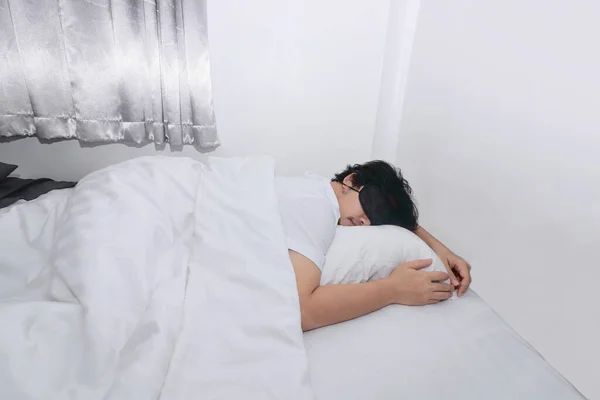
[321, 226, 446, 285]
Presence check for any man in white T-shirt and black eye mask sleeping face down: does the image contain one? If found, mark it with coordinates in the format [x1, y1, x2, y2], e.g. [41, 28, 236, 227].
[276, 161, 471, 331]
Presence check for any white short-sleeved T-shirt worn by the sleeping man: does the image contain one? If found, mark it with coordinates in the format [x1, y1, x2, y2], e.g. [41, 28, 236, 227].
[275, 173, 340, 269]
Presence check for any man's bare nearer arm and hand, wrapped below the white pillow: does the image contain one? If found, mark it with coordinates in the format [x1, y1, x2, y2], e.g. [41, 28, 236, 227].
[289, 250, 452, 331]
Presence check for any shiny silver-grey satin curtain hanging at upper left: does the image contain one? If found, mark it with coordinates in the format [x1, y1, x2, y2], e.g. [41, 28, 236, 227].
[0, 0, 219, 148]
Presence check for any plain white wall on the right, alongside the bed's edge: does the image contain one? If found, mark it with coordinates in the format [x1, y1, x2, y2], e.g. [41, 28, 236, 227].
[399, 0, 600, 400]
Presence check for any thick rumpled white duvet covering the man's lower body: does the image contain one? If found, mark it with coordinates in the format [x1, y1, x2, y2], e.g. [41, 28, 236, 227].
[0, 157, 313, 400]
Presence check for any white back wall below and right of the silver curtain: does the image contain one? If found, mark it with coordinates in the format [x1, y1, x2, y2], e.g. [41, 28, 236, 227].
[0, 0, 389, 179]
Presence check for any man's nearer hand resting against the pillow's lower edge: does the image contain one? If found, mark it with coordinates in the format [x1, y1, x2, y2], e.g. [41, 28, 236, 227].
[385, 259, 454, 306]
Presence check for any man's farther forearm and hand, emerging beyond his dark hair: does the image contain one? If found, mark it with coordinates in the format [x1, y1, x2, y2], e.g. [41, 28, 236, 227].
[415, 226, 471, 296]
